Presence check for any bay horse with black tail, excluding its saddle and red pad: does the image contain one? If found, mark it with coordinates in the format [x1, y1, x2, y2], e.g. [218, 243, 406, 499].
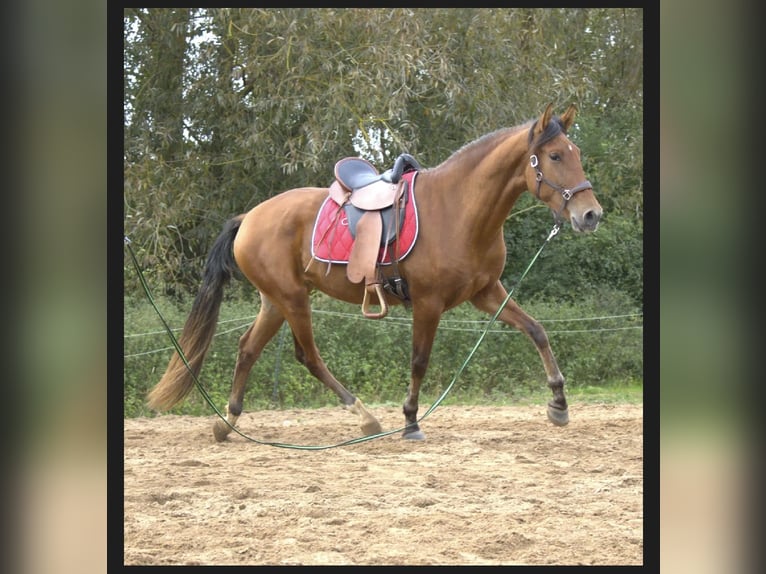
[148, 104, 602, 441]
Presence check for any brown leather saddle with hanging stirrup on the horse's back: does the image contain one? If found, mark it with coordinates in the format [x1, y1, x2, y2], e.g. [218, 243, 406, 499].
[329, 154, 421, 319]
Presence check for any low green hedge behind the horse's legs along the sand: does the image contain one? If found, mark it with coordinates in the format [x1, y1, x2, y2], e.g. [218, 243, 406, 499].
[124, 289, 643, 417]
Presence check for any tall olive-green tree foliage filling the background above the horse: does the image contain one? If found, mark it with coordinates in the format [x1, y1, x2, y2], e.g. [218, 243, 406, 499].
[124, 8, 643, 304]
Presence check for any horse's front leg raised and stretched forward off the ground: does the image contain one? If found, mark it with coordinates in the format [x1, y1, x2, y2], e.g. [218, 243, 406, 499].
[471, 281, 569, 426]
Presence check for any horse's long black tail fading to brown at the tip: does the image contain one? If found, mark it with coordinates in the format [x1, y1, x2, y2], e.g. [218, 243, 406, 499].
[148, 215, 244, 410]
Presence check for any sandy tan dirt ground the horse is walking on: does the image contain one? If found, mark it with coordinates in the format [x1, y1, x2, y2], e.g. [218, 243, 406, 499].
[124, 403, 643, 565]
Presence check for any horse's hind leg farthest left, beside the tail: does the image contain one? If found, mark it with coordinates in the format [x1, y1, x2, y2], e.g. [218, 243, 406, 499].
[213, 295, 285, 441]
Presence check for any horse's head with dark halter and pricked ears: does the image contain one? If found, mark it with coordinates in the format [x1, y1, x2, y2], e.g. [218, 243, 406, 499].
[526, 104, 603, 231]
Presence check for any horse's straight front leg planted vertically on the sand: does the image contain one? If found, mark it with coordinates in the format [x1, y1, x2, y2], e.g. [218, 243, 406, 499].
[402, 306, 442, 440]
